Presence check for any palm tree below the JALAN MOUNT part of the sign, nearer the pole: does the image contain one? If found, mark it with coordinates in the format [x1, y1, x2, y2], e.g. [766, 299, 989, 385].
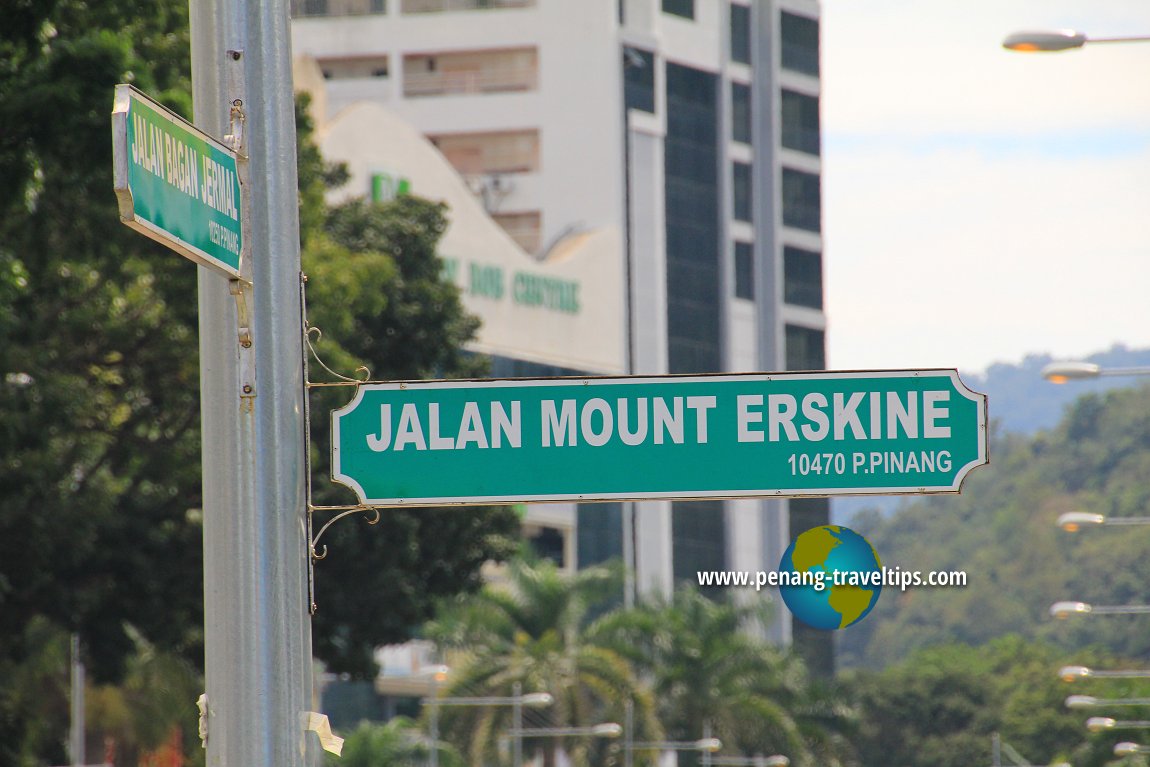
[427, 561, 661, 767]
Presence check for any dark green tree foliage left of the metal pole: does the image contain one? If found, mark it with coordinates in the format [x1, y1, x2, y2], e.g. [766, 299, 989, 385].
[0, 0, 200, 685]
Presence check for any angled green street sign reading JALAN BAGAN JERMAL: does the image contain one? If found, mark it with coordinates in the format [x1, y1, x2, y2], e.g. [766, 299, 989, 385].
[112, 85, 244, 277]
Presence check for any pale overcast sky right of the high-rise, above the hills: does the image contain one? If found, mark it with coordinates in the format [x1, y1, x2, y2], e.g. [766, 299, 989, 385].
[822, 0, 1150, 373]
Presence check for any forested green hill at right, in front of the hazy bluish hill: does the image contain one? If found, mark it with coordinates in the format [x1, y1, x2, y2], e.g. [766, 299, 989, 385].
[837, 384, 1150, 668]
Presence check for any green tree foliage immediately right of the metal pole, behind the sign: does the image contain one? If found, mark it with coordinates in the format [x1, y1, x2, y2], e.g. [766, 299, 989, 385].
[298, 110, 519, 678]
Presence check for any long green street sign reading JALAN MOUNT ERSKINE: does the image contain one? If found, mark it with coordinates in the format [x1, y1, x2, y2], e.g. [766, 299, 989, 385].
[331, 370, 988, 506]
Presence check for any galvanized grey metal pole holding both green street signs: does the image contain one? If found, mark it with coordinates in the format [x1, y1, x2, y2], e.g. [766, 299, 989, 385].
[190, 0, 316, 767]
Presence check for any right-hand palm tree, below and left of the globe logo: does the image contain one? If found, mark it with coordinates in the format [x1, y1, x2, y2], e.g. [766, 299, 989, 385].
[589, 586, 849, 767]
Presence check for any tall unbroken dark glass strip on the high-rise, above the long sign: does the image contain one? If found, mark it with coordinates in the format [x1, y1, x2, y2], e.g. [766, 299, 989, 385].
[664, 62, 726, 373]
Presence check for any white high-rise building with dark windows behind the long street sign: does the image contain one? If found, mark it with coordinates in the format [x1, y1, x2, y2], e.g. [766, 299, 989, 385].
[292, 0, 830, 668]
